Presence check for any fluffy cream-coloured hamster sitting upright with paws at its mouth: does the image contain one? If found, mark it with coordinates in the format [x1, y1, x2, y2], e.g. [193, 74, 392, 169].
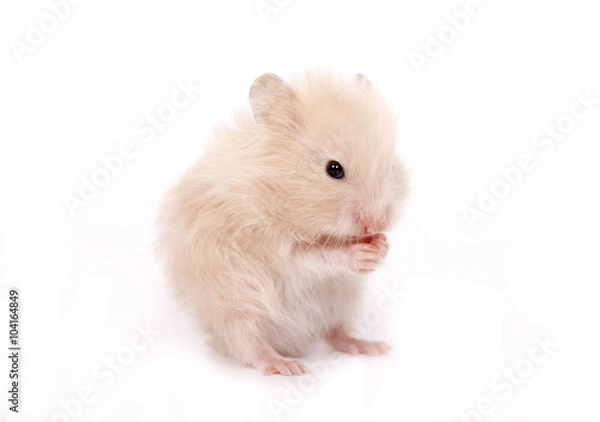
[157, 72, 407, 375]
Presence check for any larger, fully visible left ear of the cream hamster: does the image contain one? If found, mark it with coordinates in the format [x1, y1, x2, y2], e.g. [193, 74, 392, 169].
[250, 73, 300, 131]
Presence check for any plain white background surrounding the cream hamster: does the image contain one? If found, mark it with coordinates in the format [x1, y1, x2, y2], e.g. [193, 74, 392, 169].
[0, 0, 600, 422]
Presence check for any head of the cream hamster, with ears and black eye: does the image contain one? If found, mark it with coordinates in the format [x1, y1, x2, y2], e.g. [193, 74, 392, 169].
[250, 73, 407, 243]
